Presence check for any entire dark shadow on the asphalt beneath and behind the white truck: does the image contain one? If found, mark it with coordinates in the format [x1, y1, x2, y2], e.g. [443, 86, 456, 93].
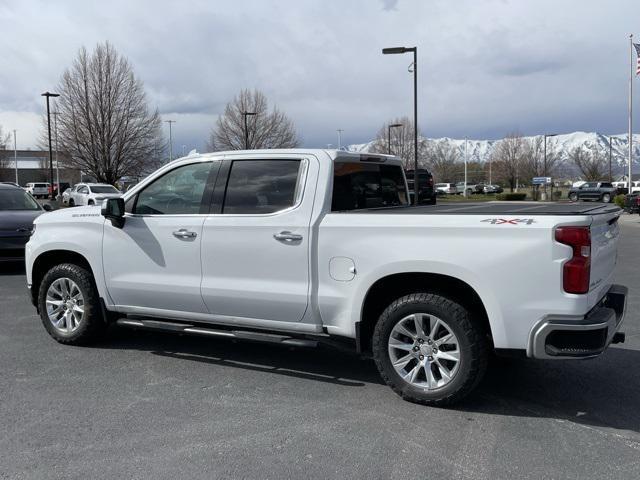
[100, 328, 640, 433]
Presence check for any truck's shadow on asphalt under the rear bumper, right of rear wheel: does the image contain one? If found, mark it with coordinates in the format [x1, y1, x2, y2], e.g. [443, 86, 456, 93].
[455, 347, 640, 432]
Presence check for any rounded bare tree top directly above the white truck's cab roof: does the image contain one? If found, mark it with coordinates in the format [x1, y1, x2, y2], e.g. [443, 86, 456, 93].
[209, 90, 300, 150]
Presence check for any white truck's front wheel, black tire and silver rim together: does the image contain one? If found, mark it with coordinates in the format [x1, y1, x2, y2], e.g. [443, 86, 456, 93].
[38, 263, 105, 345]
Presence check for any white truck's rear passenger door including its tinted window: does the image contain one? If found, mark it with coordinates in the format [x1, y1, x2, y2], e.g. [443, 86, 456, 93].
[202, 154, 317, 322]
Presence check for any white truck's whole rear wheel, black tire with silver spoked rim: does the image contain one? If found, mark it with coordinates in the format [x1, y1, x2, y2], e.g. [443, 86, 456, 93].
[373, 293, 488, 406]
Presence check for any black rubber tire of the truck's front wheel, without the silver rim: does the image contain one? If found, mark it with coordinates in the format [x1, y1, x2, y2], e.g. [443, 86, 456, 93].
[38, 263, 106, 345]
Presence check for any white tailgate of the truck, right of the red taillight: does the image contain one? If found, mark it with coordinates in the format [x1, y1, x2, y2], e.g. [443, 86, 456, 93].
[589, 210, 620, 292]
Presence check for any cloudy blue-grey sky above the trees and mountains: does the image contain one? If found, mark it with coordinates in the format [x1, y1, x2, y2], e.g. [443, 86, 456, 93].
[0, 0, 640, 151]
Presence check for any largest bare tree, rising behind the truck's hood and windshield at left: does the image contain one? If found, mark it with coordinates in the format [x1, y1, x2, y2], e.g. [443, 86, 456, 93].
[52, 42, 162, 184]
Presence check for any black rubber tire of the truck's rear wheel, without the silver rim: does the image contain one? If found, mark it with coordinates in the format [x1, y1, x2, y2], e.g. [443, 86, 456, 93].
[372, 293, 489, 406]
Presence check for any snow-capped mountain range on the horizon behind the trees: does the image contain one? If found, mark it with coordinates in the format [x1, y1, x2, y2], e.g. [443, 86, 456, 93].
[347, 132, 640, 173]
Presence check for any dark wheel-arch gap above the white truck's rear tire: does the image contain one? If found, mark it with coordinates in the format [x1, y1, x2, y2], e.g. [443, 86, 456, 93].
[356, 272, 493, 354]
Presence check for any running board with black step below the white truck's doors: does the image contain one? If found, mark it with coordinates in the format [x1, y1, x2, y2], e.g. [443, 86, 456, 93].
[116, 318, 318, 347]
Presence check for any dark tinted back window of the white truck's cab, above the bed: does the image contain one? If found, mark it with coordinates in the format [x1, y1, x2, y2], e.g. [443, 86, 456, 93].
[331, 162, 408, 212]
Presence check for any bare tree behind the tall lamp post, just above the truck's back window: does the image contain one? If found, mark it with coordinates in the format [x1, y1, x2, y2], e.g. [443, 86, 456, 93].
[370, 117, 428, 170]
